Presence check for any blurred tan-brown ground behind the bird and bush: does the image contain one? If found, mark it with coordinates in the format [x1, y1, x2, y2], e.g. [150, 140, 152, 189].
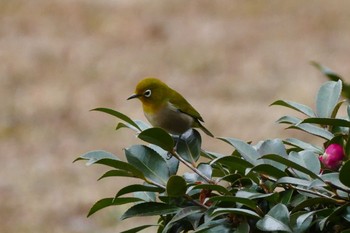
[0, 0, 350, 233]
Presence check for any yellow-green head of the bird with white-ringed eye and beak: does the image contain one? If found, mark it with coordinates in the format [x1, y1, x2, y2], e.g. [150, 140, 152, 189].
[128, 78, 169, 106]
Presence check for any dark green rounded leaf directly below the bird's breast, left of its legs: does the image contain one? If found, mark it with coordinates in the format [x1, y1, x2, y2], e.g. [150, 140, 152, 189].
[138, 128, 174, 151]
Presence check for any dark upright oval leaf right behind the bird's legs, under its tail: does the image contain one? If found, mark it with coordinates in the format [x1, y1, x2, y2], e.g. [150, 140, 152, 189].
[177, 129, 202, 164]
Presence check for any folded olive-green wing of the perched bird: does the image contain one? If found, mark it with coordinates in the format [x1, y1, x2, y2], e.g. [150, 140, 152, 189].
[169, 91, 204, 122]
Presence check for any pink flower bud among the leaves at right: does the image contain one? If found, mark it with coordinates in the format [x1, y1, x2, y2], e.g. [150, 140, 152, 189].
[319, 144, 345, 170]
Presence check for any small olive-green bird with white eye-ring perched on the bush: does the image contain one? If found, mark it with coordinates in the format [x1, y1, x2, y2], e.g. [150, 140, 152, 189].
[128, 78, 214, 137]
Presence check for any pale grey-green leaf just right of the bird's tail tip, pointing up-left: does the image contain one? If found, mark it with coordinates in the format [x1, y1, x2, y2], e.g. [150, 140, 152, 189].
[219, 137, 262, 165]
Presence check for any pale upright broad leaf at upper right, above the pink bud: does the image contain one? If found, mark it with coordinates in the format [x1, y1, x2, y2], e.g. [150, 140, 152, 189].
[316, 80, 342, 118]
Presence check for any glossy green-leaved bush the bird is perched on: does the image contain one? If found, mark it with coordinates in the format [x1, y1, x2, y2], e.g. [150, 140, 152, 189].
[77, 63, 350, 233]
